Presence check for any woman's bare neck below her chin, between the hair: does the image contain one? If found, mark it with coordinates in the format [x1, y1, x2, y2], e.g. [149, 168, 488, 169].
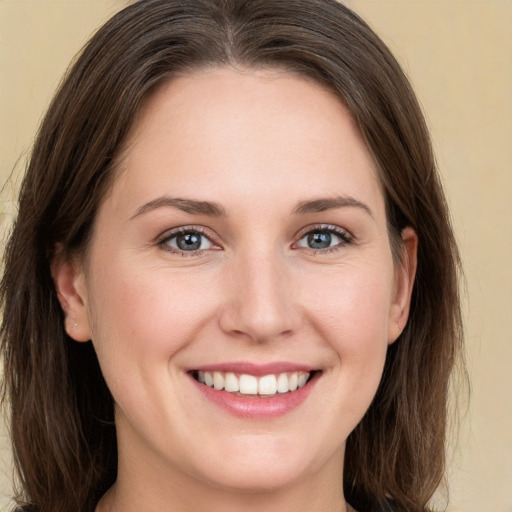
[96, 448, 348, 512]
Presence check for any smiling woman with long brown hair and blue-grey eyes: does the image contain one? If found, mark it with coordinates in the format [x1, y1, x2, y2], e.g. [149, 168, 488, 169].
[1, 0, 461, 512]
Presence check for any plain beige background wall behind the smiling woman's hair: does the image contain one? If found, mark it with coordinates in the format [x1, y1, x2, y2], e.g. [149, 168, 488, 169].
[0, 0, 512, 512]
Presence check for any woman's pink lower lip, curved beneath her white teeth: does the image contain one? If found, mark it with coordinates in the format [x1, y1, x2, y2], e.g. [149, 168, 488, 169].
[190, 372, 320, 419]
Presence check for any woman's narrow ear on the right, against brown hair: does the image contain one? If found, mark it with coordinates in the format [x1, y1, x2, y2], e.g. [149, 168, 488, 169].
[388, 227, 418, 344]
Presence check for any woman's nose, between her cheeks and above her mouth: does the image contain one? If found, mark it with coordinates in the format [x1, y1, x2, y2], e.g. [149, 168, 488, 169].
[219, 249, 302, 343]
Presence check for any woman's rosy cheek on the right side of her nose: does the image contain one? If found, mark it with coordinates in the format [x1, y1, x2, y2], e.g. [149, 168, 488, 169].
[303, 263, 393, 388]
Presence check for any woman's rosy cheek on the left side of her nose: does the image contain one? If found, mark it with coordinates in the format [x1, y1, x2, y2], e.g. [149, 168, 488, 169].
[83, 260, 218, 386]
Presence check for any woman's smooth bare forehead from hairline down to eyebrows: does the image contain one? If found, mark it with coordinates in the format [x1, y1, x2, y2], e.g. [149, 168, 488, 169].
[108, 68, 382, 218]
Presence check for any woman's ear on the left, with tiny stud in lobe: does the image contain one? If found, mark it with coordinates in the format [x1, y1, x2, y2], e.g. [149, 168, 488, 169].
[51, 244, 91, 341]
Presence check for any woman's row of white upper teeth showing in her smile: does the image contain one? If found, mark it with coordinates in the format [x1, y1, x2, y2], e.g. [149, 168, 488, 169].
[197, 371, 309, 395]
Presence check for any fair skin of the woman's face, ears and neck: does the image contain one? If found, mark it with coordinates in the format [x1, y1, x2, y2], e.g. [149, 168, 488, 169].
[52, 68, 417, 512]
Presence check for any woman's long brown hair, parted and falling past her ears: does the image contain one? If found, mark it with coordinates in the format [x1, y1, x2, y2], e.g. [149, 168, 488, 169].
[0, 0, 462, 512]
